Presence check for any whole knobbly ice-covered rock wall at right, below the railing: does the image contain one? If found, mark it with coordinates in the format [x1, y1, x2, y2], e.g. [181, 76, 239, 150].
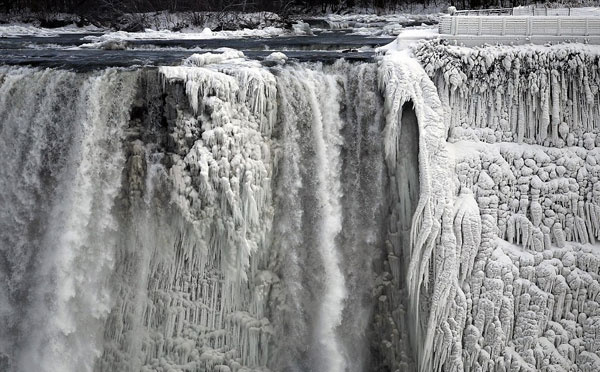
[415, 42, 600, 371]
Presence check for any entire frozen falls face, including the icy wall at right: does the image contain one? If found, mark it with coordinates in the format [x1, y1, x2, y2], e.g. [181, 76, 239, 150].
[0, 41, 600, 372]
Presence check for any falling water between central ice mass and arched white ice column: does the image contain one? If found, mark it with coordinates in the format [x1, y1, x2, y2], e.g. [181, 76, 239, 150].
[274, 63, 383, 371]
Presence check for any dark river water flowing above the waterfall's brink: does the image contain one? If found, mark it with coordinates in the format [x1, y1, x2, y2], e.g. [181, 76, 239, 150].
[0, 30, 394, 70]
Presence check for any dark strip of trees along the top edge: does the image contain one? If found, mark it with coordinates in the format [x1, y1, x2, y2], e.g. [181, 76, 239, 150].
[0, 0, 584, 16]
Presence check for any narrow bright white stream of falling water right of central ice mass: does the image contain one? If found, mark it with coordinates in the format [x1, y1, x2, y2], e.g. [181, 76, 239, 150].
[306, 70, 346, 372]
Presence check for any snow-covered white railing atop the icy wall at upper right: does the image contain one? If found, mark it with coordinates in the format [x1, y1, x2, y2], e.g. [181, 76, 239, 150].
[439, 16, 600, 36]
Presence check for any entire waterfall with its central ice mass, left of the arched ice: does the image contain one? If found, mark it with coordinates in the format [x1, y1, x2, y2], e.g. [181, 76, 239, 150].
[0, 53, 443, 372]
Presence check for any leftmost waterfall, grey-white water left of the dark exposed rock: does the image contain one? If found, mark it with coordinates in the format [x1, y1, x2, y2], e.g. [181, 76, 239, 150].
[0, 68, 136, 371]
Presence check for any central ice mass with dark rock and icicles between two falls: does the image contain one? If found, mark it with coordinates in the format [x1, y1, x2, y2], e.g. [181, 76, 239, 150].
[97, 60, 278, 371]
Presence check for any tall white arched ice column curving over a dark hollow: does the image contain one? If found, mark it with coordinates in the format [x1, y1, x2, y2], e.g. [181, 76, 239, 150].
[379, 52, 457, 371]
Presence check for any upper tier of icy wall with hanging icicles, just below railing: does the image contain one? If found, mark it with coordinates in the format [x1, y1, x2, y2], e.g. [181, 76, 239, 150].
[415, 42, 600, 149]
